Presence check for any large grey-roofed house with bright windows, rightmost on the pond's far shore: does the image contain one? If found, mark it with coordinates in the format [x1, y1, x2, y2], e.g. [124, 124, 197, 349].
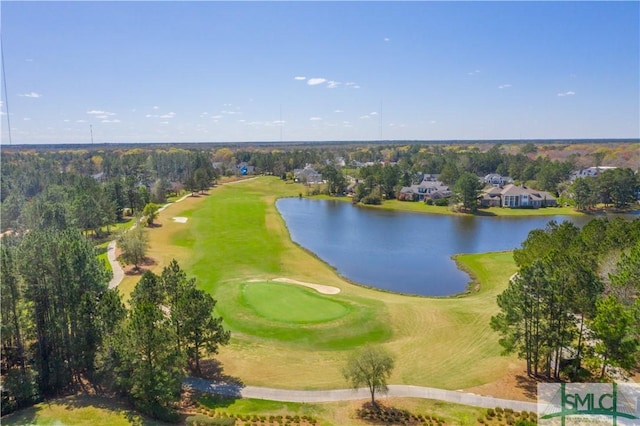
[479, 184, 558, 208]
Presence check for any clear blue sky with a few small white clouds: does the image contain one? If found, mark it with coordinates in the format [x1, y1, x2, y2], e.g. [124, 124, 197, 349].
[0, 1, 640, 144]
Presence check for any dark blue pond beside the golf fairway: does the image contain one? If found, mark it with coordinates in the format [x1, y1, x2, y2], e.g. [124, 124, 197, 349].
[276, 198, 591, 296]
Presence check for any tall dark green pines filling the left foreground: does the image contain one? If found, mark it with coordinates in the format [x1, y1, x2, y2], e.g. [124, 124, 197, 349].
[0, 223, 229, 420]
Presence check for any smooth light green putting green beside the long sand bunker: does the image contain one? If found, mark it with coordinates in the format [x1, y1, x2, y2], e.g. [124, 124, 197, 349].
[242, 282, 352, 324]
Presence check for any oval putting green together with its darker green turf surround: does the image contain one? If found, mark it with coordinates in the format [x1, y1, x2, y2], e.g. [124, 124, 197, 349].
[214, 283, 392, 350]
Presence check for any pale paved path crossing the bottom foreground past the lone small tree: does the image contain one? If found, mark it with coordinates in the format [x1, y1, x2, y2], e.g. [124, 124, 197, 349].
[183, 377, 536, 411]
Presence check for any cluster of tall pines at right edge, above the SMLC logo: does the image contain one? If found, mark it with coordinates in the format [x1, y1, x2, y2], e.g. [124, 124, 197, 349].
[491, 218, 640, 380]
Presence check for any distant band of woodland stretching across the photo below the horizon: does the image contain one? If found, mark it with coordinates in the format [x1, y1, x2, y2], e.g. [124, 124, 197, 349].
[0, 142, 638, 232]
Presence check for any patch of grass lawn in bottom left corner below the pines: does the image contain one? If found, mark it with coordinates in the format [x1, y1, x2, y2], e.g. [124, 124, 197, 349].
[2, 396, 166, 426]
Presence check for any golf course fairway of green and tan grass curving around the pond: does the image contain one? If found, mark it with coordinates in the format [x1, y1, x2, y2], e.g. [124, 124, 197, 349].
[119, 177, 526, 399]
